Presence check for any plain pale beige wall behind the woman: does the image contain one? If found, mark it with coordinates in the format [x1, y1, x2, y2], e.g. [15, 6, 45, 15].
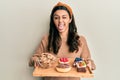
[0, 0, 120, 80]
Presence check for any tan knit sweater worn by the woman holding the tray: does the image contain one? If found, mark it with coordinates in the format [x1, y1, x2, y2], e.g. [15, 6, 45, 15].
[29, 35, 91, 80]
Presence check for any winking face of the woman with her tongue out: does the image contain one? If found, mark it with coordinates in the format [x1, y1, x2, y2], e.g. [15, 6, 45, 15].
[53, 10, 71, 33]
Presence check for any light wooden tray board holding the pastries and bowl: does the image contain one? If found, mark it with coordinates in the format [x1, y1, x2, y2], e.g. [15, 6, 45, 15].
[33, 58, 94, 78]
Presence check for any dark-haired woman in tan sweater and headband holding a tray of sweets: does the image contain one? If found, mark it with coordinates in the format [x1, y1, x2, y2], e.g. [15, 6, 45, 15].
[29, 2, 95, 80]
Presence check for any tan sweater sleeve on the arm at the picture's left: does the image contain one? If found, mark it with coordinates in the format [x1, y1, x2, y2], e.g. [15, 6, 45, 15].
[29, 36, 48, 66]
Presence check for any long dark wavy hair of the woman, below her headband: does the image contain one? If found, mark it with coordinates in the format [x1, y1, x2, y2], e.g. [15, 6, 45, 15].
[48, 6, 80, 54]
